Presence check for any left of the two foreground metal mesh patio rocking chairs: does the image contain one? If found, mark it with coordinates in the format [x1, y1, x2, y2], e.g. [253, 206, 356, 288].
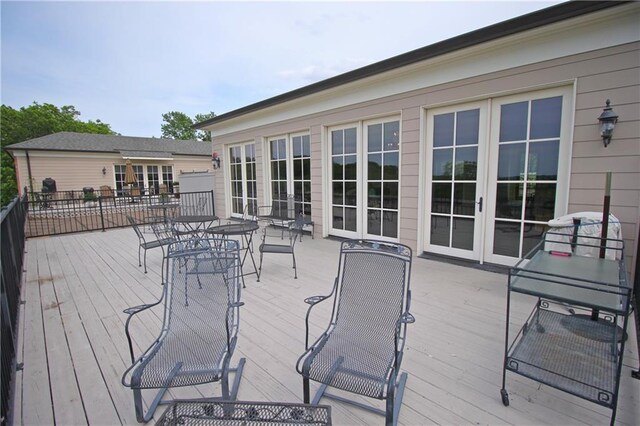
[122, 239, 245, 422]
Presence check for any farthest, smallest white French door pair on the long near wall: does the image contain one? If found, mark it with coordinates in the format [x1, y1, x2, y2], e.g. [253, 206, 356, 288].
[229, 143, 258, 217]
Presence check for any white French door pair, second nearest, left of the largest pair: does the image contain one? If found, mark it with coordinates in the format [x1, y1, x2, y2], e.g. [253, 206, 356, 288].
[329, 118, 400, 241]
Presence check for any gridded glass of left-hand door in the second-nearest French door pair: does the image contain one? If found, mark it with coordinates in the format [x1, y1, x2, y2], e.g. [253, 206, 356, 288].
[330, 127, 358, 237]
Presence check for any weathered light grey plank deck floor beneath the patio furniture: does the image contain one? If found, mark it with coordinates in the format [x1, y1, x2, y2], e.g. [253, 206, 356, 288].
[14, 229, 640, 425]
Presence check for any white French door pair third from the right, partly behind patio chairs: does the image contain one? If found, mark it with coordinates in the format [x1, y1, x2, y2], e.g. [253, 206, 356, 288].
[269, 134, 311, 217]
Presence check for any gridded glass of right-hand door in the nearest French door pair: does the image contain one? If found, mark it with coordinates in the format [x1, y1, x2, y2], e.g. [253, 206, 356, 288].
[491, 96, 563, 258]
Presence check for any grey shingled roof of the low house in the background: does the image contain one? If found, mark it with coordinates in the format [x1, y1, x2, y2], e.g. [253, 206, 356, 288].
[5, 132, 211, 158]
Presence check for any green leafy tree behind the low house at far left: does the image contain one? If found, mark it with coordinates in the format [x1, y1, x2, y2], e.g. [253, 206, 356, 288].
[0, 102, 115, 206]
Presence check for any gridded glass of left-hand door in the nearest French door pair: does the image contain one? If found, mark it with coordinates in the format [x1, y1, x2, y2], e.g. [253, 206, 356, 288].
[428, 108, 484, 259]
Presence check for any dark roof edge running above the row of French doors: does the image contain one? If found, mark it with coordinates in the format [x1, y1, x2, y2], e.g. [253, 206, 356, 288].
[193, 1, 630, 129]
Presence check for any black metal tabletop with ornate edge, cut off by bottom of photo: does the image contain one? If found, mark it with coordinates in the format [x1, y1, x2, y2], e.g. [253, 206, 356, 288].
[156, 400, 332, 426]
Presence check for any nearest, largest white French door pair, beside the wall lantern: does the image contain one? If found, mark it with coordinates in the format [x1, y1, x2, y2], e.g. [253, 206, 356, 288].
[424, 88, 573, 265]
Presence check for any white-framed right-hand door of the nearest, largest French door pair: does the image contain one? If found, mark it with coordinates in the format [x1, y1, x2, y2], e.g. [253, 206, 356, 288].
[485, 89, 571, 264]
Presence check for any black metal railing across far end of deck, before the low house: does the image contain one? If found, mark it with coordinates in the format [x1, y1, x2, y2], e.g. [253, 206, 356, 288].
[26, 191, 215, 237]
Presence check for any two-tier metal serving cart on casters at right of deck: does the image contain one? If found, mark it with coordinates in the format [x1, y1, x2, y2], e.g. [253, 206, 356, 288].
[500, 232, 631, 425]
